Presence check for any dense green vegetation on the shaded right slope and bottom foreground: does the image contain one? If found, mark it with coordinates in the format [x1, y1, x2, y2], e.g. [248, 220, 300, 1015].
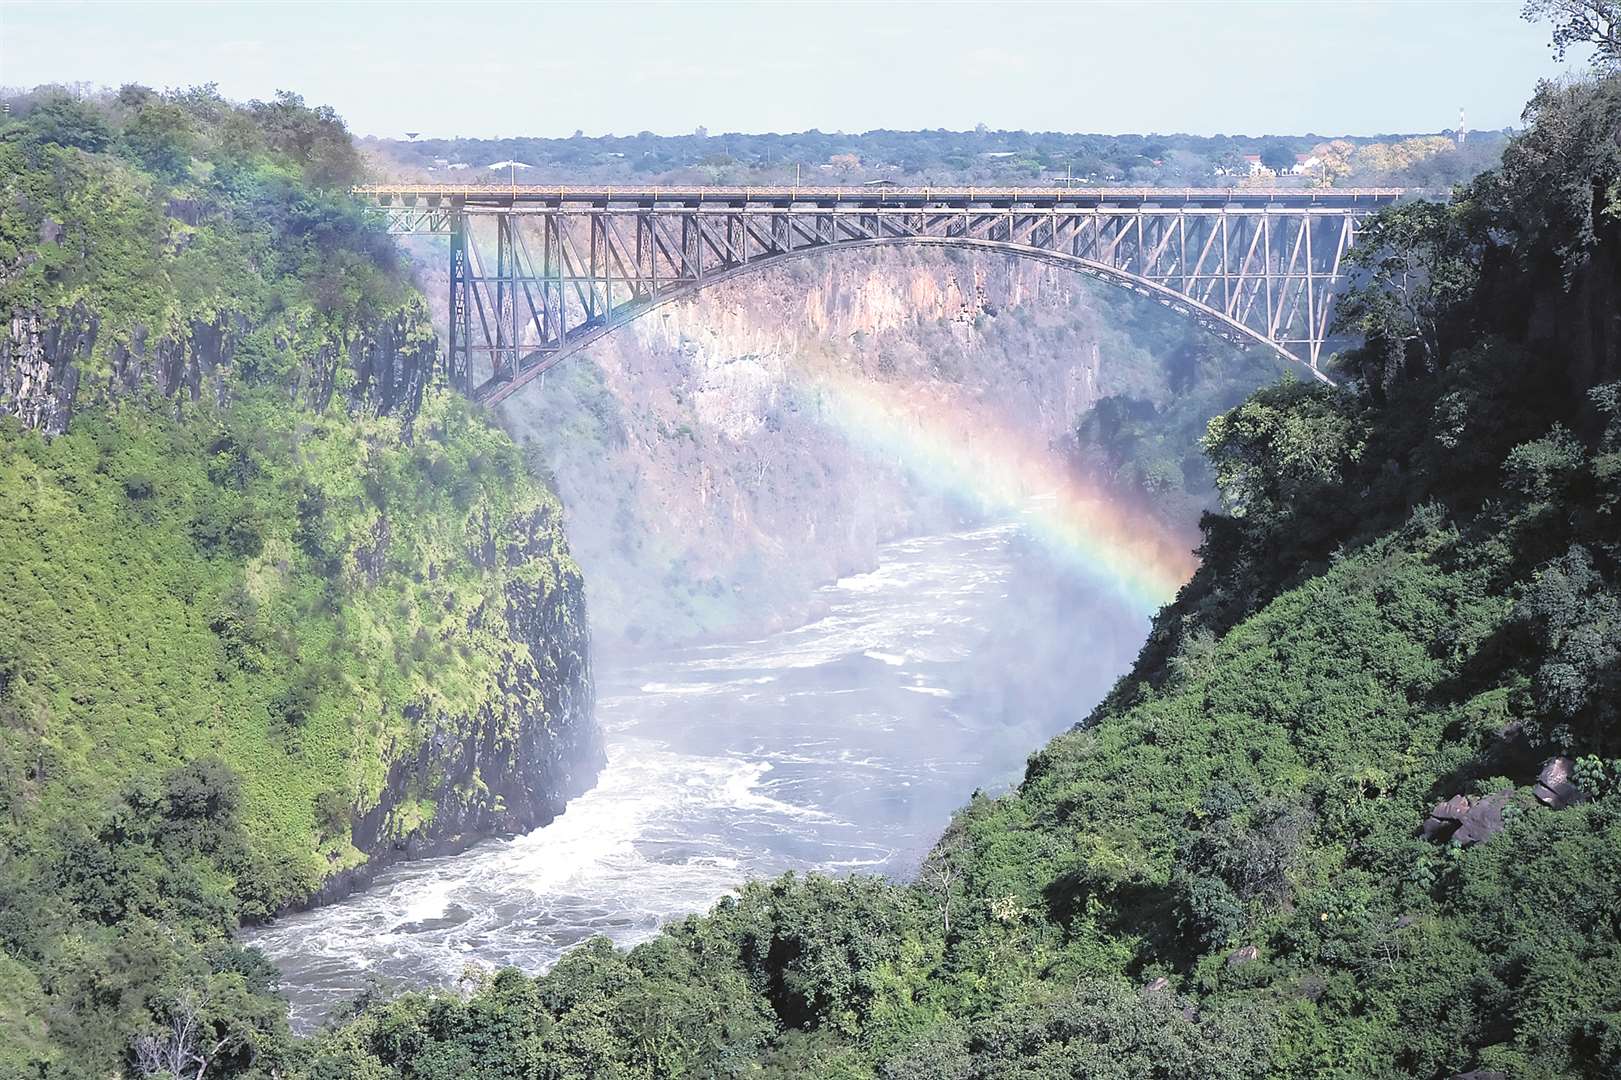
[297, 67, 1621, 1080]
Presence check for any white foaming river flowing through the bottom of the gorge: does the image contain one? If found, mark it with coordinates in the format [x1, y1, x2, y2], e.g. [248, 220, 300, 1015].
[243, 522, 1148, 1030]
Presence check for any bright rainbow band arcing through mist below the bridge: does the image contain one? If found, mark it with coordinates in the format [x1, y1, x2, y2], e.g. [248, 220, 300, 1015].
[799, 371, 1198, 613]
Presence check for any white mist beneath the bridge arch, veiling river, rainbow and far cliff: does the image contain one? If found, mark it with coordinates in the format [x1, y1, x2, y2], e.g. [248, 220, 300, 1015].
[250, 245, 1277, 1028]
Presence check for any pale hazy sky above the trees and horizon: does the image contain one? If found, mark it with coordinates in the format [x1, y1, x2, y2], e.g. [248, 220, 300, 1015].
[0, 0, 1559, 136]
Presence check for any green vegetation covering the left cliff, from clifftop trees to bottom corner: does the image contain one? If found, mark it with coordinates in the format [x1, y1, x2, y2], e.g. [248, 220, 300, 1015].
[0, 88, 584, 1078]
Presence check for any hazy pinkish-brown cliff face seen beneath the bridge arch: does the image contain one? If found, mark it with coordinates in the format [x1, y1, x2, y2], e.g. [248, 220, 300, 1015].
[417, 245, 1276, 649]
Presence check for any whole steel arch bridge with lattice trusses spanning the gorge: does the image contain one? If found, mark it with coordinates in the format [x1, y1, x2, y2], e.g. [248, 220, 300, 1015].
[355, 185, 1402, 404]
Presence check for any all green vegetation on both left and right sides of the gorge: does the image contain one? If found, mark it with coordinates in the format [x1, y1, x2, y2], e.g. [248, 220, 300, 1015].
[0, 10, 1621, 1080]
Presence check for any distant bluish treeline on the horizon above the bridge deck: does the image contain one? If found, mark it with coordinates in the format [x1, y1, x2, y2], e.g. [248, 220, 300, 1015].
[360, 126, 1511, 191]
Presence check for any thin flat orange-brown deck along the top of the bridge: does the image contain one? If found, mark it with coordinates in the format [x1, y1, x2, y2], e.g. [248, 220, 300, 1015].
[355, 183, 1407, 209]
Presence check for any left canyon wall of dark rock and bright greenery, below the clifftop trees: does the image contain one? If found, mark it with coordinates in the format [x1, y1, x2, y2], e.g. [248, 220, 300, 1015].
[0, 298, 603, 911]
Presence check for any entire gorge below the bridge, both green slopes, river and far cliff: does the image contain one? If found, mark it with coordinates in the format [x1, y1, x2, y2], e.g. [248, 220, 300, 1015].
[0, 18, 1621, 1080]
